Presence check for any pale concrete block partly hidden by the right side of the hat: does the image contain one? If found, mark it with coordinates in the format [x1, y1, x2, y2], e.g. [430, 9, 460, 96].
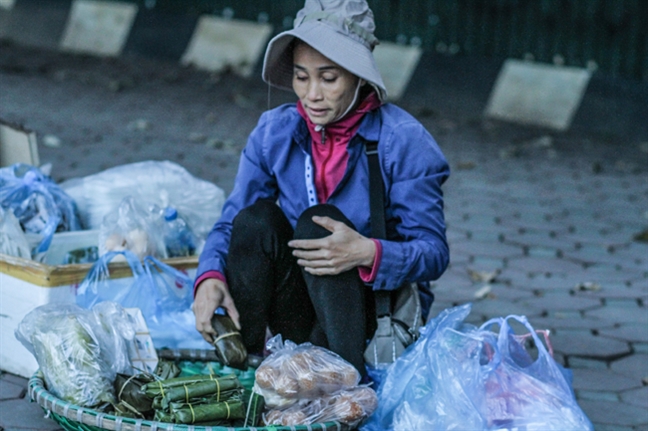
[374, 42, 422, 100]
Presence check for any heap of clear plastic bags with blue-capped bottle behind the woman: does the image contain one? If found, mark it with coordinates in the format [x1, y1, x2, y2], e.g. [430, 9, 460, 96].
[61, 161, 225, 259]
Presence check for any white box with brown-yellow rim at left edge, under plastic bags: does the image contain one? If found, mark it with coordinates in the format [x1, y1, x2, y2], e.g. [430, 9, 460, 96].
[0, 246, 198, 377]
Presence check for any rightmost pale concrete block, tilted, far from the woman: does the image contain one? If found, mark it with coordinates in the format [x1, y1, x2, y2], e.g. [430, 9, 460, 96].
[484, 59, 592, 130]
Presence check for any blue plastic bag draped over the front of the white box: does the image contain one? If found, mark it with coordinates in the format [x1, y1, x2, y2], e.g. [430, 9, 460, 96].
[76, 250, 213, 349]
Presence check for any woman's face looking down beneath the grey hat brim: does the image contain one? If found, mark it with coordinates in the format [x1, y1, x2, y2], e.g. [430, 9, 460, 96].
[293, 43, 358, 126]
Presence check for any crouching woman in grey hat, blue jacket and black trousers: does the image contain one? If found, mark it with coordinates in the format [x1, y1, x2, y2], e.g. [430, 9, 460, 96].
[194, 0, 449, 375]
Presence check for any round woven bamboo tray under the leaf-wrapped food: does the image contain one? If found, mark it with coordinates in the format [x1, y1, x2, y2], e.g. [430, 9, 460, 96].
[28, 350, 350, 431]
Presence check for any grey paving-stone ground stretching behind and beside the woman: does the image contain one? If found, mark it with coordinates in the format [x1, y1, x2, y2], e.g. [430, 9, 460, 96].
[0, 41, 648, 431]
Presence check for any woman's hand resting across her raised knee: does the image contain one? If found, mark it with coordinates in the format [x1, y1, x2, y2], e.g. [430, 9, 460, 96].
[288, 216, 376, 275]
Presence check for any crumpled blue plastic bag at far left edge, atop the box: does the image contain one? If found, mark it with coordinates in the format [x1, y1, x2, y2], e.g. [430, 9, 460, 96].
[0, 163, 81, 254]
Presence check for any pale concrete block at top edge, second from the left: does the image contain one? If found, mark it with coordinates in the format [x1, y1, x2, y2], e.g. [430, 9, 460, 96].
[60, 0, 138, 56]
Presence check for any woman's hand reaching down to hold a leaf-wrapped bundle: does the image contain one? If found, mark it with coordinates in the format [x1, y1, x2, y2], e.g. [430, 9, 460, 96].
[191, 278, 241, 344]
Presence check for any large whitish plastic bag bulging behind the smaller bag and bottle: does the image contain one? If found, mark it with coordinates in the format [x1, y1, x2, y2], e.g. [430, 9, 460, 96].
[61, 161, 225, 253]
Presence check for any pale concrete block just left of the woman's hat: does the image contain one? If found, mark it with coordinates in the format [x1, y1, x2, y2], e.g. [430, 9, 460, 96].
[181, 15, 272, 77]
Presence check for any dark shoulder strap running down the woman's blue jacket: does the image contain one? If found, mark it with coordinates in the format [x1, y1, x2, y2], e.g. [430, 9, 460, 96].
[365, 142, 391, 317]
